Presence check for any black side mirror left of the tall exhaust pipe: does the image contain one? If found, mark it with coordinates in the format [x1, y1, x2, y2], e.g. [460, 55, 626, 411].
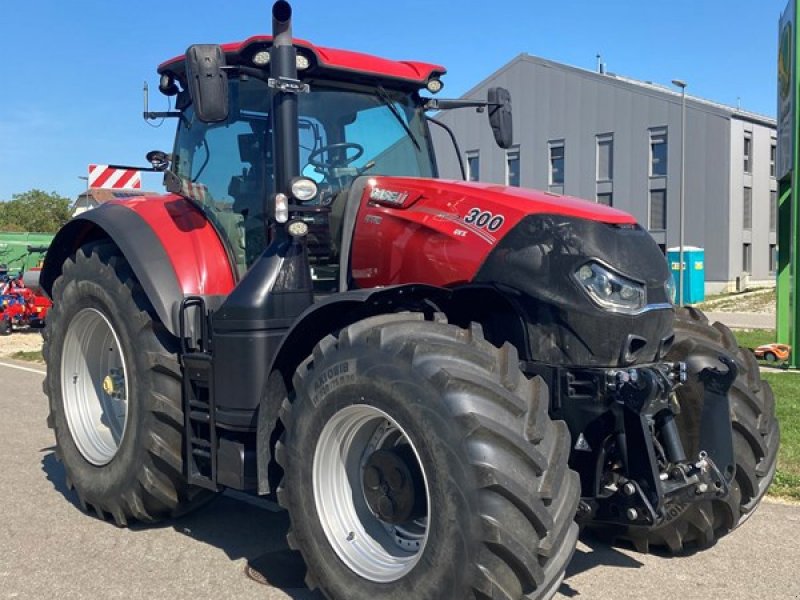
[186, 44, 228, 123]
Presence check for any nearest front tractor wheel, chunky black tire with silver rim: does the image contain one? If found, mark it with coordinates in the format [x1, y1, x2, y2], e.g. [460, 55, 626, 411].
[276, 313, 580, 600]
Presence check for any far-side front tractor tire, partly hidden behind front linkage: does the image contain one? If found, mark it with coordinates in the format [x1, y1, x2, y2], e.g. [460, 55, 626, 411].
[604, 308, 780, 554]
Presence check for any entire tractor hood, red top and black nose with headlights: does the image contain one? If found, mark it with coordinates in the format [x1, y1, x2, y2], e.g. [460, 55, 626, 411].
[350, 177, 672, 366]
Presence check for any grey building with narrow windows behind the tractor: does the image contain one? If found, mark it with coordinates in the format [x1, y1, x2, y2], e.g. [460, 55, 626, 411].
[433, 54, 777, 293]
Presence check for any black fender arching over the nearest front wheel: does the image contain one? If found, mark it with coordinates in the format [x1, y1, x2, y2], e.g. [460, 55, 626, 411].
[256, 284, 528, 494]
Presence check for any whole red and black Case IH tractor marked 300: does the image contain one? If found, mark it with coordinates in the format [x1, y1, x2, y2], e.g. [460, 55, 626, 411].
[41, 1, 779, 600]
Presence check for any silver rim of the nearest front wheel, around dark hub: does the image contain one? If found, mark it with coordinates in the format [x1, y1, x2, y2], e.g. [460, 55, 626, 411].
[312, 405, 431, 583]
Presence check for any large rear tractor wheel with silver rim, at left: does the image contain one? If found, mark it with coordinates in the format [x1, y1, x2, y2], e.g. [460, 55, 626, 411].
[43, 243, 210, 527]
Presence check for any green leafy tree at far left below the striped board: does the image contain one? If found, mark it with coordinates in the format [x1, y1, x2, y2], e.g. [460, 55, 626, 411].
[0, 189, 70, 233]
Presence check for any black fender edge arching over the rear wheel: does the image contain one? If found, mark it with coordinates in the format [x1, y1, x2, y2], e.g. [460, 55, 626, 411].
[40, 204, 183, 336]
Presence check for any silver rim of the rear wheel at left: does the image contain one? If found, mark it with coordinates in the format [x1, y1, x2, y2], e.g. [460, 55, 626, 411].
[61, 308, 128, 466]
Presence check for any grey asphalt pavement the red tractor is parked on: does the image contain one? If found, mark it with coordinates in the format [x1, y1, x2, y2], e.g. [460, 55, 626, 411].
[0, 360, 800, 600]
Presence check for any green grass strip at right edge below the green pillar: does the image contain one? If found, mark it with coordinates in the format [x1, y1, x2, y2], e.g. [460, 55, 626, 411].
[761, 372, 800, 500]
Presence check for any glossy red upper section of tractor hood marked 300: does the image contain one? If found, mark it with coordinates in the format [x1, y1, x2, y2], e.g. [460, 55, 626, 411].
[352, 176, 644, 288]
